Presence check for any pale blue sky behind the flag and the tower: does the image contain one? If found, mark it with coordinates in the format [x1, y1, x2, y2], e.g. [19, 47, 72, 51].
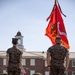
[0, 0, 75, 52]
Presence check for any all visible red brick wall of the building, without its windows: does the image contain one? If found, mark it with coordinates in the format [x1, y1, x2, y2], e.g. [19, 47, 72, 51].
[0, 58, 75, 75]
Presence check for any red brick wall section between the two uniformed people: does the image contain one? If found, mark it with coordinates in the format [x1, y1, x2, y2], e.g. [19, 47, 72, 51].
[25, 58, 45, 75]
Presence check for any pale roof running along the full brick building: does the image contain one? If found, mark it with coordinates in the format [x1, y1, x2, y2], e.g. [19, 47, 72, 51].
[0, 51, 75, 59]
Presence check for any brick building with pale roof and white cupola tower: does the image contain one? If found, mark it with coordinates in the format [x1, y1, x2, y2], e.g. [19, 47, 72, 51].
[0, 32, 75, 75]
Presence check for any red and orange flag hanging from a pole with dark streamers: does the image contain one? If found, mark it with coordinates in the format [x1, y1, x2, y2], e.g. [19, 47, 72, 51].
[45, 3, 69, 49]
